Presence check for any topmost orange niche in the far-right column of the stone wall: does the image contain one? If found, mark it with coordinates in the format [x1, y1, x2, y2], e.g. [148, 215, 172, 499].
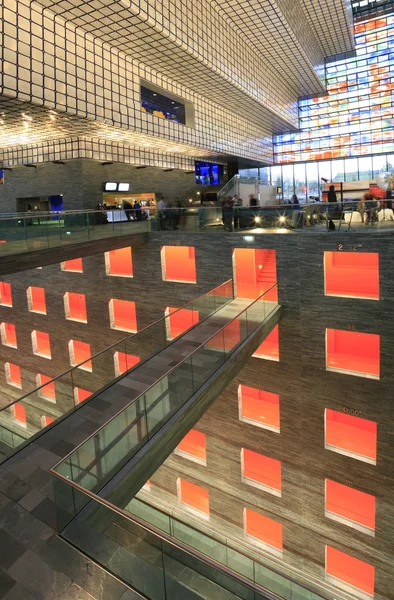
[324, 252, 379, 300]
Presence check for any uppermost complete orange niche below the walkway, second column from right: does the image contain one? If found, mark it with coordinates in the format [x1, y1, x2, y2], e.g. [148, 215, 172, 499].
[238, 385, 280, 433]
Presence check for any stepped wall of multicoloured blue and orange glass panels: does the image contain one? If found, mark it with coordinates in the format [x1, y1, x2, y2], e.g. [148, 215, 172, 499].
[274, 10, 394, 163]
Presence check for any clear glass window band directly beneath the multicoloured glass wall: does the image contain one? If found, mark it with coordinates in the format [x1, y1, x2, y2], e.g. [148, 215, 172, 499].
[266, 154, 394, 202]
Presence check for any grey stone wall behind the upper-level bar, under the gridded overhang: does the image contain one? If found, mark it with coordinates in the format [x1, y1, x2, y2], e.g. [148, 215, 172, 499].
[0, 160, 197, 212]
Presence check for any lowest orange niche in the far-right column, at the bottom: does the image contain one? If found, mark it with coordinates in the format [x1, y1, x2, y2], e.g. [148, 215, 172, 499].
[326, 546, 375, 597]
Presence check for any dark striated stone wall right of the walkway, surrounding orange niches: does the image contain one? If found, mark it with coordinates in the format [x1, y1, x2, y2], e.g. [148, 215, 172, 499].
[144, 233, 394, 600]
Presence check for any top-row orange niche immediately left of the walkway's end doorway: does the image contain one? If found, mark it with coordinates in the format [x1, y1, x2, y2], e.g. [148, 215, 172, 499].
[161, 246, 197, 283]
